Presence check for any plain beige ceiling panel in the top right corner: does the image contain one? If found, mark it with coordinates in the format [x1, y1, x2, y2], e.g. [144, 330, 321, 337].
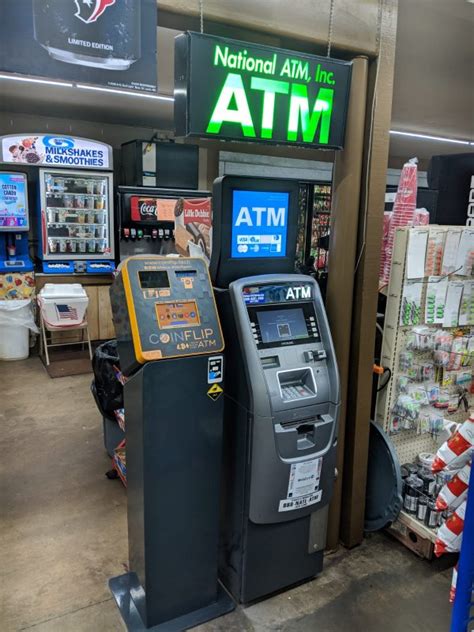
[392, 0, 474, 140]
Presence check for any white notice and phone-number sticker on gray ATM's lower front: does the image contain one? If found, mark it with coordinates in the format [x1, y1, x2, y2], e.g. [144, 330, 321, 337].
[278, 457, 323, 511]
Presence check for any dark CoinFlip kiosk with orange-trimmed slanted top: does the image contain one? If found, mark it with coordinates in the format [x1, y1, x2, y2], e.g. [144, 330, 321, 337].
[110, 255, 234, 632]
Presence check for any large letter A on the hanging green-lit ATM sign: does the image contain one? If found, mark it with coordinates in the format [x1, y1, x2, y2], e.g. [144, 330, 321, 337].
[206, 73, 255, 138]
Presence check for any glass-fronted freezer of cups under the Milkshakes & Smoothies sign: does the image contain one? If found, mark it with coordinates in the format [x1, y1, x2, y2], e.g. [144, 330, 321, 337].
[39, 169, 115, 274]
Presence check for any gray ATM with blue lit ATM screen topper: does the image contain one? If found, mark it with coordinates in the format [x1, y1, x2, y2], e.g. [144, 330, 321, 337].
[211, 177, 340, 603]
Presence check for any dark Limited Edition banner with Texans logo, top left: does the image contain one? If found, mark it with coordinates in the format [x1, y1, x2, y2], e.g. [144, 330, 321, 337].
[0, 0, 158, 94]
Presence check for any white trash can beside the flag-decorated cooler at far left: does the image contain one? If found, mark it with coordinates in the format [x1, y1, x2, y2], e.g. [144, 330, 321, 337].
[0, 298, 38, 360]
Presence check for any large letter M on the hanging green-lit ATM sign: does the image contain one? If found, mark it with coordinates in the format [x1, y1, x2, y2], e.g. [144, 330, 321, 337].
[287, 83, 334, 145]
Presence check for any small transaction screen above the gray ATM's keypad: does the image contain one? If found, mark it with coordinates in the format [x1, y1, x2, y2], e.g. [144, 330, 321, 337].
[257, 307, 309, 344]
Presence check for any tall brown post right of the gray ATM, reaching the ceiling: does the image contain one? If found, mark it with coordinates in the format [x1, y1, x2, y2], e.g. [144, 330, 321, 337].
[340, 0, 398, 547]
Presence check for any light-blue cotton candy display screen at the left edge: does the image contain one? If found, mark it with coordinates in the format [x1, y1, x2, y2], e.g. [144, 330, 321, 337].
[0, 172, 29, 231]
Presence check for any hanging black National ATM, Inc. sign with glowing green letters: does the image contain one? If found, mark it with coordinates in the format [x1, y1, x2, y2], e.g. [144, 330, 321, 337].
[174, 33, 351, 149]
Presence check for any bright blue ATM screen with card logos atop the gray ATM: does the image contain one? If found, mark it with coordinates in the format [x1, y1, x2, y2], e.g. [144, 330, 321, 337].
[231, 189, 290, 259]
